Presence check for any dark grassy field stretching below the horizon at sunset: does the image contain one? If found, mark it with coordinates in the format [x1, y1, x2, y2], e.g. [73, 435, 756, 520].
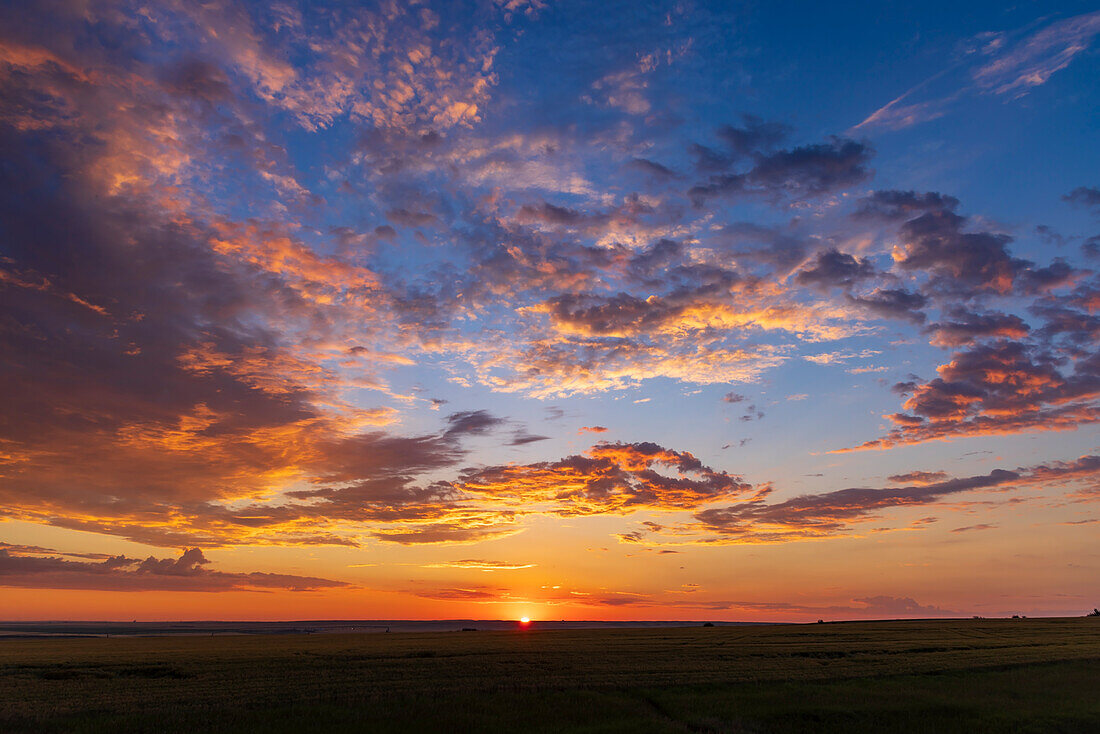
[0, 618, 1100, 733]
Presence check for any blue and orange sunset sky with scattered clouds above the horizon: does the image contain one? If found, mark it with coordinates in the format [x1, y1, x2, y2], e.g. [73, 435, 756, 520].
[0, 0, 1100, 621]
